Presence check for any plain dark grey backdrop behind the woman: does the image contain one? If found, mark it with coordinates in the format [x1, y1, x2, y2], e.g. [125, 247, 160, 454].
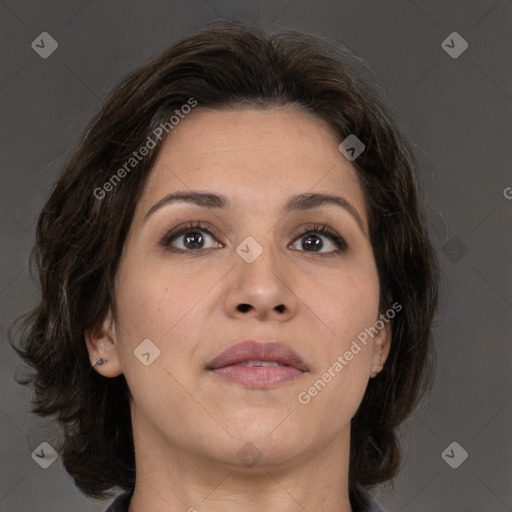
[0, 0, 512, 512]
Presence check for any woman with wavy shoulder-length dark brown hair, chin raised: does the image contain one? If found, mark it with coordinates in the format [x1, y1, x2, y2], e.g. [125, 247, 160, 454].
[12, 22, 438, 512]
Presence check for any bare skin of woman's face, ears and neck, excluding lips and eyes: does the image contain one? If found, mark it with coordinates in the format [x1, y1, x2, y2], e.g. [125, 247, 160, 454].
[86, 107, 391, 512]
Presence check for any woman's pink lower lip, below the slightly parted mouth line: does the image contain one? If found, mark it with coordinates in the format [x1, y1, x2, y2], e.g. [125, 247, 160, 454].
[211, 365, 304, 388]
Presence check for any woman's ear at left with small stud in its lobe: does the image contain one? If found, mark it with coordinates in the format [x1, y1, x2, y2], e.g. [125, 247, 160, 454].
[84, 308, 123, 377]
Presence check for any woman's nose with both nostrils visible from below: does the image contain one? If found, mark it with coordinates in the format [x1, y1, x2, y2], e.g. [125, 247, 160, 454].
[225, 236, 298, 321]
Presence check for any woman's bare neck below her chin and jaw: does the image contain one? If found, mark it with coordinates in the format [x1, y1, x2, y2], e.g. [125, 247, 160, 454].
[128, 411, 352, 512]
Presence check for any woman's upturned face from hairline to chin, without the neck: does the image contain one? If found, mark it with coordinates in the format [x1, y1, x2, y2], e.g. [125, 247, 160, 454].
[88, 108, 389, 470]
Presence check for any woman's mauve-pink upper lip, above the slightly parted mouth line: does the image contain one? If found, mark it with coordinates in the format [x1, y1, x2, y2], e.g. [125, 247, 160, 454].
[206, 340, 308, 372]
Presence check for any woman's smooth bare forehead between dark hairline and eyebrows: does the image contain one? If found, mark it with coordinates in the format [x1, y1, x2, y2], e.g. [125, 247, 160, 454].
[140, 107, 366, 221]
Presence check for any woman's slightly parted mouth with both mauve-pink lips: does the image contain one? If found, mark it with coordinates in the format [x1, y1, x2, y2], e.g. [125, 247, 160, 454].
[206, 340, 309, 389]
